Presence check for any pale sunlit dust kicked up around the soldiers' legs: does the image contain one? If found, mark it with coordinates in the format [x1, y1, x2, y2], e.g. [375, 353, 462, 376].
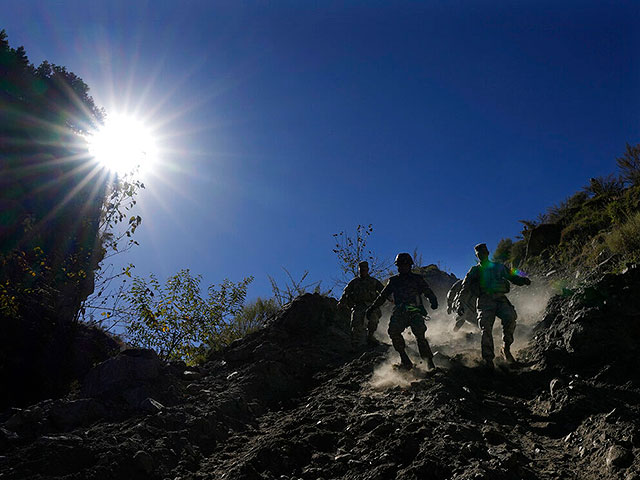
[369, 278, 559, 390]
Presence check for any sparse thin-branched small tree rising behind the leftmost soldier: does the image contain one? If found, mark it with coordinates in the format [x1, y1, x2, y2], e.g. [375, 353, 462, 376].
[333, 224, 392, 286]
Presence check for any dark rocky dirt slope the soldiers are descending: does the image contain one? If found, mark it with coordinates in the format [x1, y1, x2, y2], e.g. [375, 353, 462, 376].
[0, 268, 640, 480]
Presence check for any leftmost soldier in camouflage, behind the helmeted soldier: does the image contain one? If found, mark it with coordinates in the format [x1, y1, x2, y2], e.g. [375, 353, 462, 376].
[338, 262, 384, 347]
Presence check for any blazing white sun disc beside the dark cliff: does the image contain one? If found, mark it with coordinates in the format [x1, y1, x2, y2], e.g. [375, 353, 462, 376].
[89, 115, 158, 175]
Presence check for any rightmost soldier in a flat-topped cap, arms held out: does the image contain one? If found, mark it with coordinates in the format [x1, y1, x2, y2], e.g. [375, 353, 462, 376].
[460, 243, 531, 369]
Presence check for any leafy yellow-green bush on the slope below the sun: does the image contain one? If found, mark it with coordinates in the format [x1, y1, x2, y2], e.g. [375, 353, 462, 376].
[126, 269, 253, 363]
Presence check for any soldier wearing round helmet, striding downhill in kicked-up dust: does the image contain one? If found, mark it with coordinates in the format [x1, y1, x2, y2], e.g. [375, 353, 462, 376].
[367, 253, 438, 370]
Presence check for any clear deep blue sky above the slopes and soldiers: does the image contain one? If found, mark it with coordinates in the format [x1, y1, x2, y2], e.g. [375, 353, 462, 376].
[0, 0, 640, 297]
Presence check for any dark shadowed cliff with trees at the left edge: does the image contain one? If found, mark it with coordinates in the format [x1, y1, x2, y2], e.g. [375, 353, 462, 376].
[0, 31, 108, 409]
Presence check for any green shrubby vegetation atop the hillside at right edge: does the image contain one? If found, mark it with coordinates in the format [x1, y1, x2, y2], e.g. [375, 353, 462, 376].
[494, 144, 640, 272]
